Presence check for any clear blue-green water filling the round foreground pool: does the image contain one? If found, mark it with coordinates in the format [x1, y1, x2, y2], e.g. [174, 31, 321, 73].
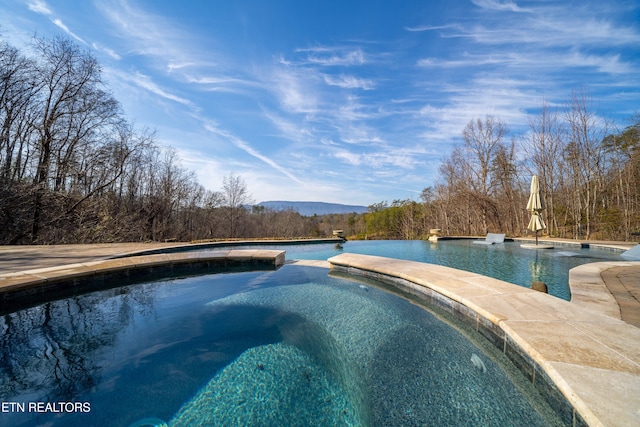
[0, 265, 558, 426]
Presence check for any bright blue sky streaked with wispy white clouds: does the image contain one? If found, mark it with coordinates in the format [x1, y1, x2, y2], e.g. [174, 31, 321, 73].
[0, 0, 640, 205]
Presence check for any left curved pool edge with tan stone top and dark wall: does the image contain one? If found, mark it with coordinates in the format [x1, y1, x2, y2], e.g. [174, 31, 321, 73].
[0, 249, 285, 313]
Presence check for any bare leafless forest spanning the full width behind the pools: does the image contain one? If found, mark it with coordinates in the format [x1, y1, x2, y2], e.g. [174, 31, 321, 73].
[0, 37, 640, 244]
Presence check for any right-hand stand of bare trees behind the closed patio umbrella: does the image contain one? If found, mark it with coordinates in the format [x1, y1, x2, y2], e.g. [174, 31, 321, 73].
[358, 103, 640, 241]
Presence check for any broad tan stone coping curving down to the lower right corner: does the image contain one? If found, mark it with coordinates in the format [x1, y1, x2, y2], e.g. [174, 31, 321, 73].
[328, 253, 640, 426]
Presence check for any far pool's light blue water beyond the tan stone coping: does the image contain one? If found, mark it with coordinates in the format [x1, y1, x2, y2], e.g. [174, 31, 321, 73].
[228, 240, 624, 300]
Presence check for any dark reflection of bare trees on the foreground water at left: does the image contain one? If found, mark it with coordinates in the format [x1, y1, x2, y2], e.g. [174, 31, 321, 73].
[0, 287, 153, 402]
